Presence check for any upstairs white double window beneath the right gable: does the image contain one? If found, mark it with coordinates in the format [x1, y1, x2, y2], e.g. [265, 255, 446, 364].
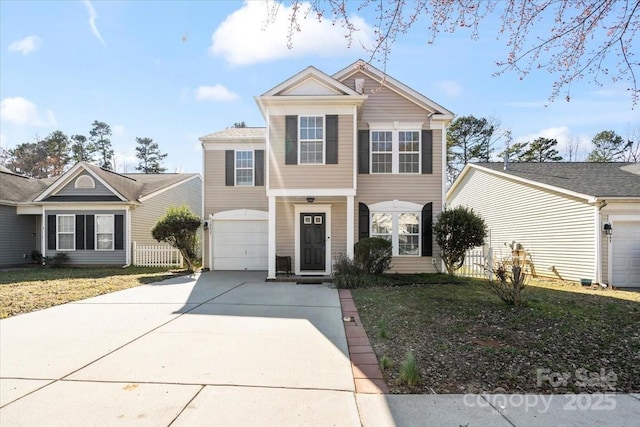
[370, 130, 421, 174]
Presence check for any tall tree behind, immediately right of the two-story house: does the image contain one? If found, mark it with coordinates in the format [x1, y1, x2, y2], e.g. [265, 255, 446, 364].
[447, 116, 495, 182]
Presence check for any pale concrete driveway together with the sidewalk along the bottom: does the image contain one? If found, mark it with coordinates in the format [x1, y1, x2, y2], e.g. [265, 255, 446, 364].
[0, 272, 640, 427]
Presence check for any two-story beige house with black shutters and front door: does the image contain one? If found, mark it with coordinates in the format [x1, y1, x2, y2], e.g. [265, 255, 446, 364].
[200, 61, 454, 278]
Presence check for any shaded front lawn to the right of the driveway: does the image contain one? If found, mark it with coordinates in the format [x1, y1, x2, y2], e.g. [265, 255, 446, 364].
[352, 278, 640, 393]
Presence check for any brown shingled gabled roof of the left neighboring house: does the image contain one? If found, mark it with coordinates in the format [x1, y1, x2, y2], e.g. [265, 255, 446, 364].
[0, 162, 199, 203]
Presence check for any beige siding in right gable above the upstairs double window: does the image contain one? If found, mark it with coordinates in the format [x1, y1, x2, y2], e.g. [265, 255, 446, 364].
[342, 73, 431, 126]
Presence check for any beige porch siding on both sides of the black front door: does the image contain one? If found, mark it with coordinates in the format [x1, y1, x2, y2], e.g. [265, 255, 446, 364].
[276, 202, 347, 266]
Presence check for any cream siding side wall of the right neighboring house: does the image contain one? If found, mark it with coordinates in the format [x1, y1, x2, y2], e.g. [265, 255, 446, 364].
[449, 169, 596, 280]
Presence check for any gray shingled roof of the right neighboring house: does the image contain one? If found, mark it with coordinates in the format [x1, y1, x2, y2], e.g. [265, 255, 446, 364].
[449, 162, 640, 198]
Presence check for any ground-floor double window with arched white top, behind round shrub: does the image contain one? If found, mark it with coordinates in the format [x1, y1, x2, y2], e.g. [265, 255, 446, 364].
[370, 212, 421, 256]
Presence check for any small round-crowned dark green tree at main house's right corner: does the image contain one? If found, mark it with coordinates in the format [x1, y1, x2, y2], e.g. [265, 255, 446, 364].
[433, 206, 487, 274]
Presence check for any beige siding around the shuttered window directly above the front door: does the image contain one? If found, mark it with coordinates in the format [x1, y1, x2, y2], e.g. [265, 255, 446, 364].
[269, 114, 354, 189]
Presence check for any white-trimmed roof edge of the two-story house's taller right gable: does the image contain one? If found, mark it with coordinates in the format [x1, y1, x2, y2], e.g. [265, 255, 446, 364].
[332, 59, 455, 120]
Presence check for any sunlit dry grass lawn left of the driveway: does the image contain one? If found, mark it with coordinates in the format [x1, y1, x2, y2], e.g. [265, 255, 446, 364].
[0, 267, 185, 319]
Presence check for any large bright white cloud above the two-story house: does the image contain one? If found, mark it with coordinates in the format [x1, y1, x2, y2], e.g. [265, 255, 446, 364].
[209, 1, 373, 65]
